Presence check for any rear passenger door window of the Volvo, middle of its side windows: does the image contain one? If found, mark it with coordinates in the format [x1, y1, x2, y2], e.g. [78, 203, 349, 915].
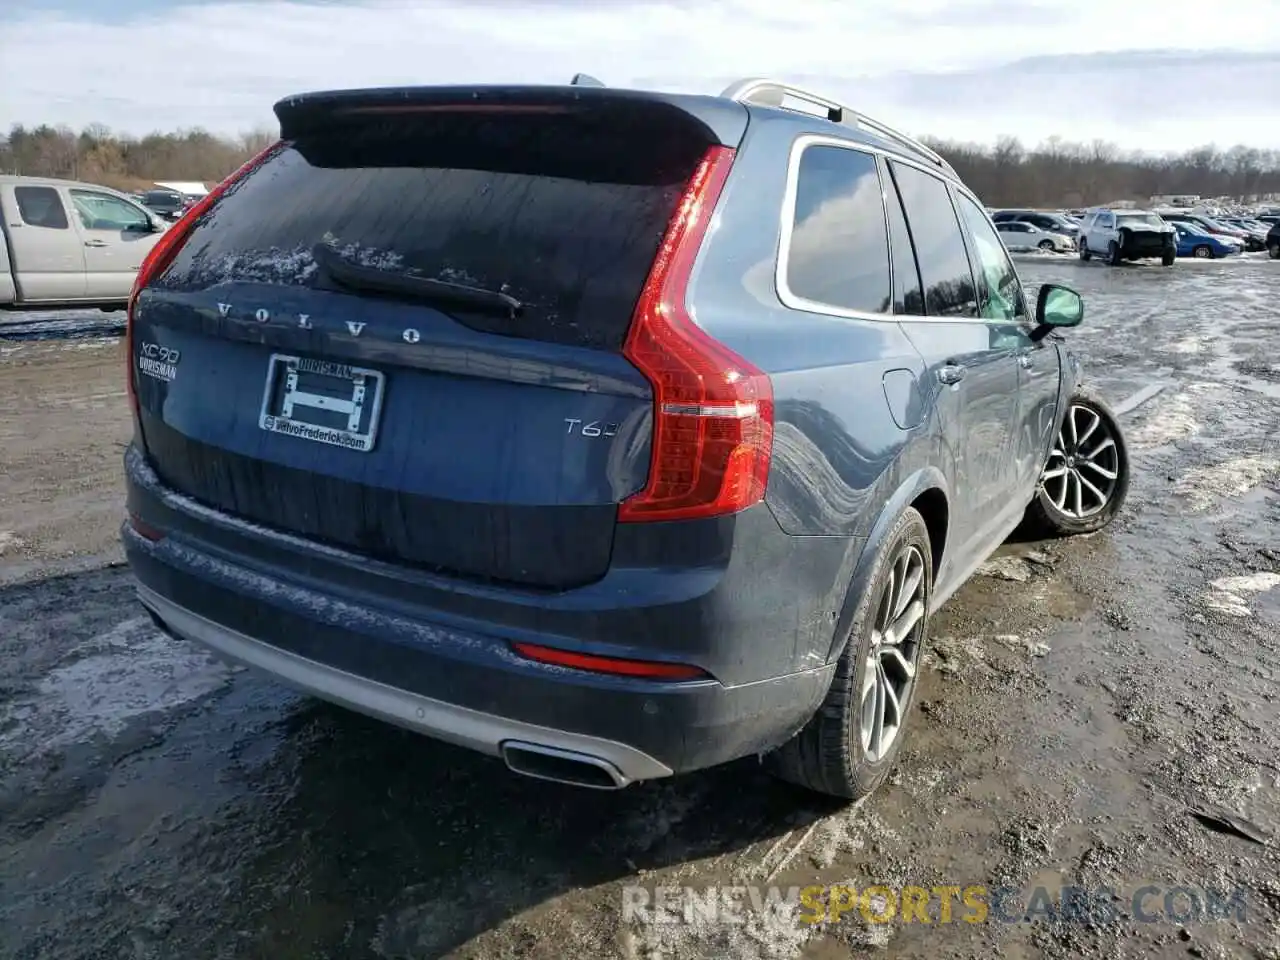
[890, 160, 978, 317]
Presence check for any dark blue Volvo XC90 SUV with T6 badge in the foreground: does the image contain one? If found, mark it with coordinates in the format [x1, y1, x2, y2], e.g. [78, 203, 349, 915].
[122, 81, 1128, 797]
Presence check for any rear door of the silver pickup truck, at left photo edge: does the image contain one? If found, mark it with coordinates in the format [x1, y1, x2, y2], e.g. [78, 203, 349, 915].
[0, 183, 84, 301]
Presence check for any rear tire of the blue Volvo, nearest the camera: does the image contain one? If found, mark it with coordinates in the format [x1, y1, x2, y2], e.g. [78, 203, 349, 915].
[764, 507, 933, 800]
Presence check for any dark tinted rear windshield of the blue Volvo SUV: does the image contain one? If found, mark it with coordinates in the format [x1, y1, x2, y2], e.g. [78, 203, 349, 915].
[160, 111, 705, 348]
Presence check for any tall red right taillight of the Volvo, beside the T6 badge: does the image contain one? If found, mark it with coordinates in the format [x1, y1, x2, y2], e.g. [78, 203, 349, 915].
[618, 146, 773, 522]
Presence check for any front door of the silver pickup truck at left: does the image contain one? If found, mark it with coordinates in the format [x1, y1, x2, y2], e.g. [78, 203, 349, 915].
[68, 187, 160, 300]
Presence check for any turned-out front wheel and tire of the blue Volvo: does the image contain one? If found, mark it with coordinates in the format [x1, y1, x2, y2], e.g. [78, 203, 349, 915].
[1027, 389, 1129, 536]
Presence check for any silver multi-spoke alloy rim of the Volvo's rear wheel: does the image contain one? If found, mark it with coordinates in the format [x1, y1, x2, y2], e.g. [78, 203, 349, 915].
[859, 545, 927, 763]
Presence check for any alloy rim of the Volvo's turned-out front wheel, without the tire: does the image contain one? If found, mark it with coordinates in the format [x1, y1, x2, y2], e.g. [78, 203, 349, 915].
[1041, 403, 1120, 520]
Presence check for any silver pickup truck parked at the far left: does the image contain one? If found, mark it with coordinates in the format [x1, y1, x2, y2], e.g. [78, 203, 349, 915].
[0, 175, 168, 310]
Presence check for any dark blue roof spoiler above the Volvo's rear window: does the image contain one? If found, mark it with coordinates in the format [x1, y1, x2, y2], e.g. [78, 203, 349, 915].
[274, 83, 748, 148]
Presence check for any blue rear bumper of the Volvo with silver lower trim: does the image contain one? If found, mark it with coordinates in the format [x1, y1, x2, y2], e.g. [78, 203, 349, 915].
[122, 442, 833, 786]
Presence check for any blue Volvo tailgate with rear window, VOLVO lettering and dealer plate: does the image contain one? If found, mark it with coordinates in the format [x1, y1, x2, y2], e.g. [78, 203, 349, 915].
[133, 93, 745, 589]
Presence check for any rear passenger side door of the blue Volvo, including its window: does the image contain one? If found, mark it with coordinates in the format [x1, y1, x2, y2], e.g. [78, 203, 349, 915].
[887, 160, 1019, 562]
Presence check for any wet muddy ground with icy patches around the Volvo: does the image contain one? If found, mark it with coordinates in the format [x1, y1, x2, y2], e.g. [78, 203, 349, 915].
[0, 257, 1280, 960]
